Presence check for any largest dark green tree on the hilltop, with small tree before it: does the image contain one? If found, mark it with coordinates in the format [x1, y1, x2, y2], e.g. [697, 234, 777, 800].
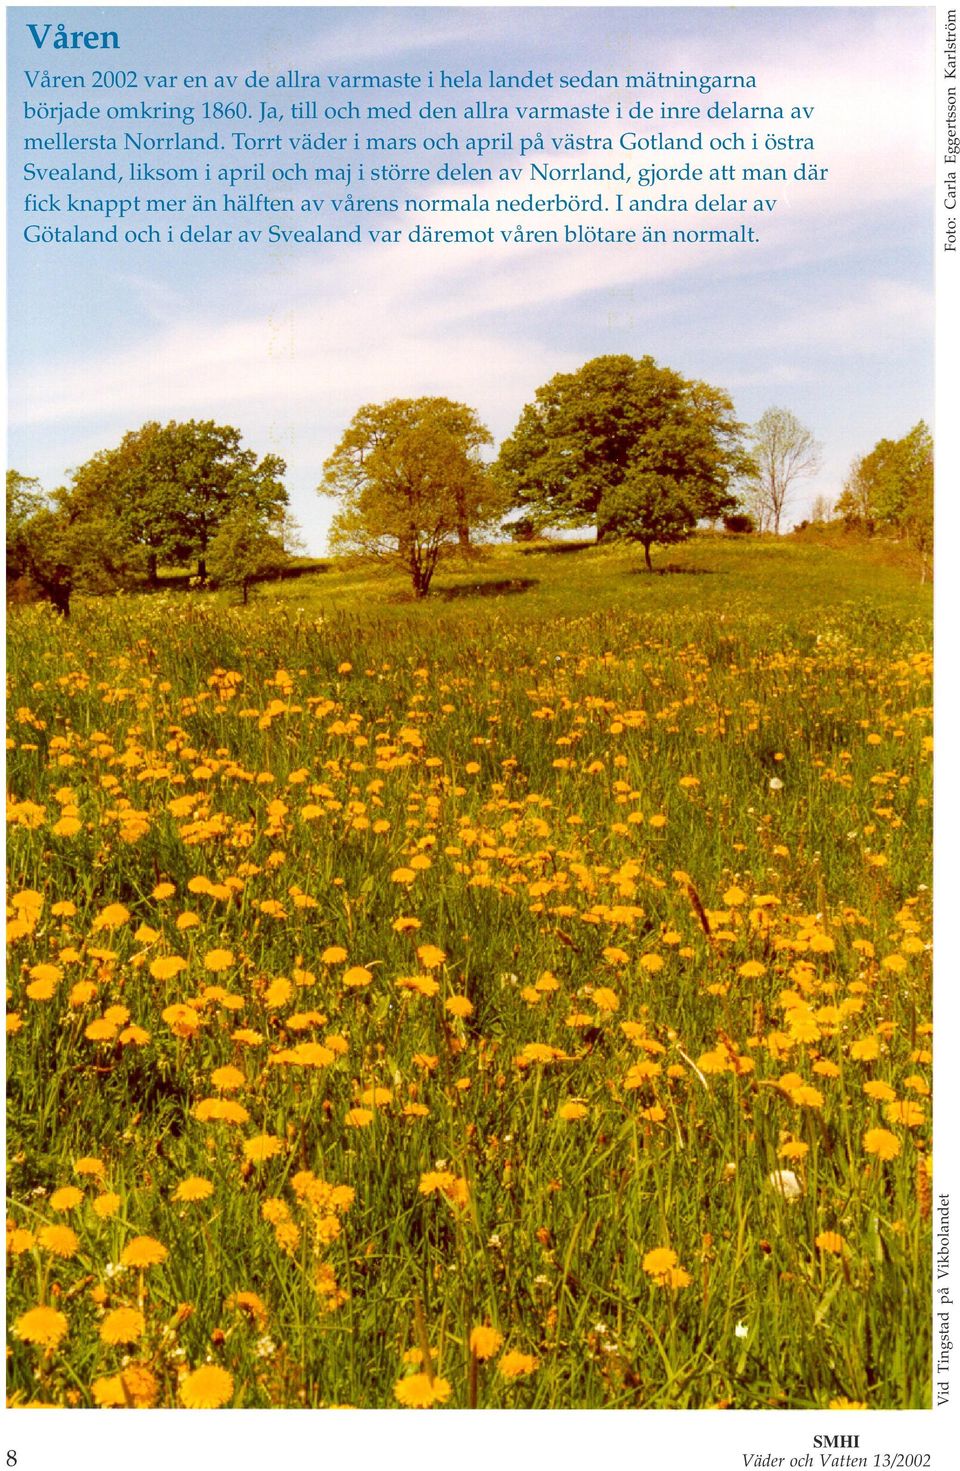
[497, 355, 747, 560]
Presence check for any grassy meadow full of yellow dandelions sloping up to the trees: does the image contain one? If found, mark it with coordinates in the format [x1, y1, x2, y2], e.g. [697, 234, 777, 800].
[7, 537, 932, 1409]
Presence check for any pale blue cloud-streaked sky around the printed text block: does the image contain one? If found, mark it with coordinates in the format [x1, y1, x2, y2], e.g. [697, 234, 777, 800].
[7, 7, 935, 552]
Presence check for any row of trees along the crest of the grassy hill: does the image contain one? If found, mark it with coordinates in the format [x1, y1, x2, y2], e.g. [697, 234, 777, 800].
[7, 355, 932, 613]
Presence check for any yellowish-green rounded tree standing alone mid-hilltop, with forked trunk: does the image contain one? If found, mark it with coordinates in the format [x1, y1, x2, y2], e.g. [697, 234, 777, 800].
[319, 397, 503, 597]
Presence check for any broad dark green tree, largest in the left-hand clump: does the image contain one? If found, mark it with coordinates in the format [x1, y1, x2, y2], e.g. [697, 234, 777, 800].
[69, 419, 287, 577]
